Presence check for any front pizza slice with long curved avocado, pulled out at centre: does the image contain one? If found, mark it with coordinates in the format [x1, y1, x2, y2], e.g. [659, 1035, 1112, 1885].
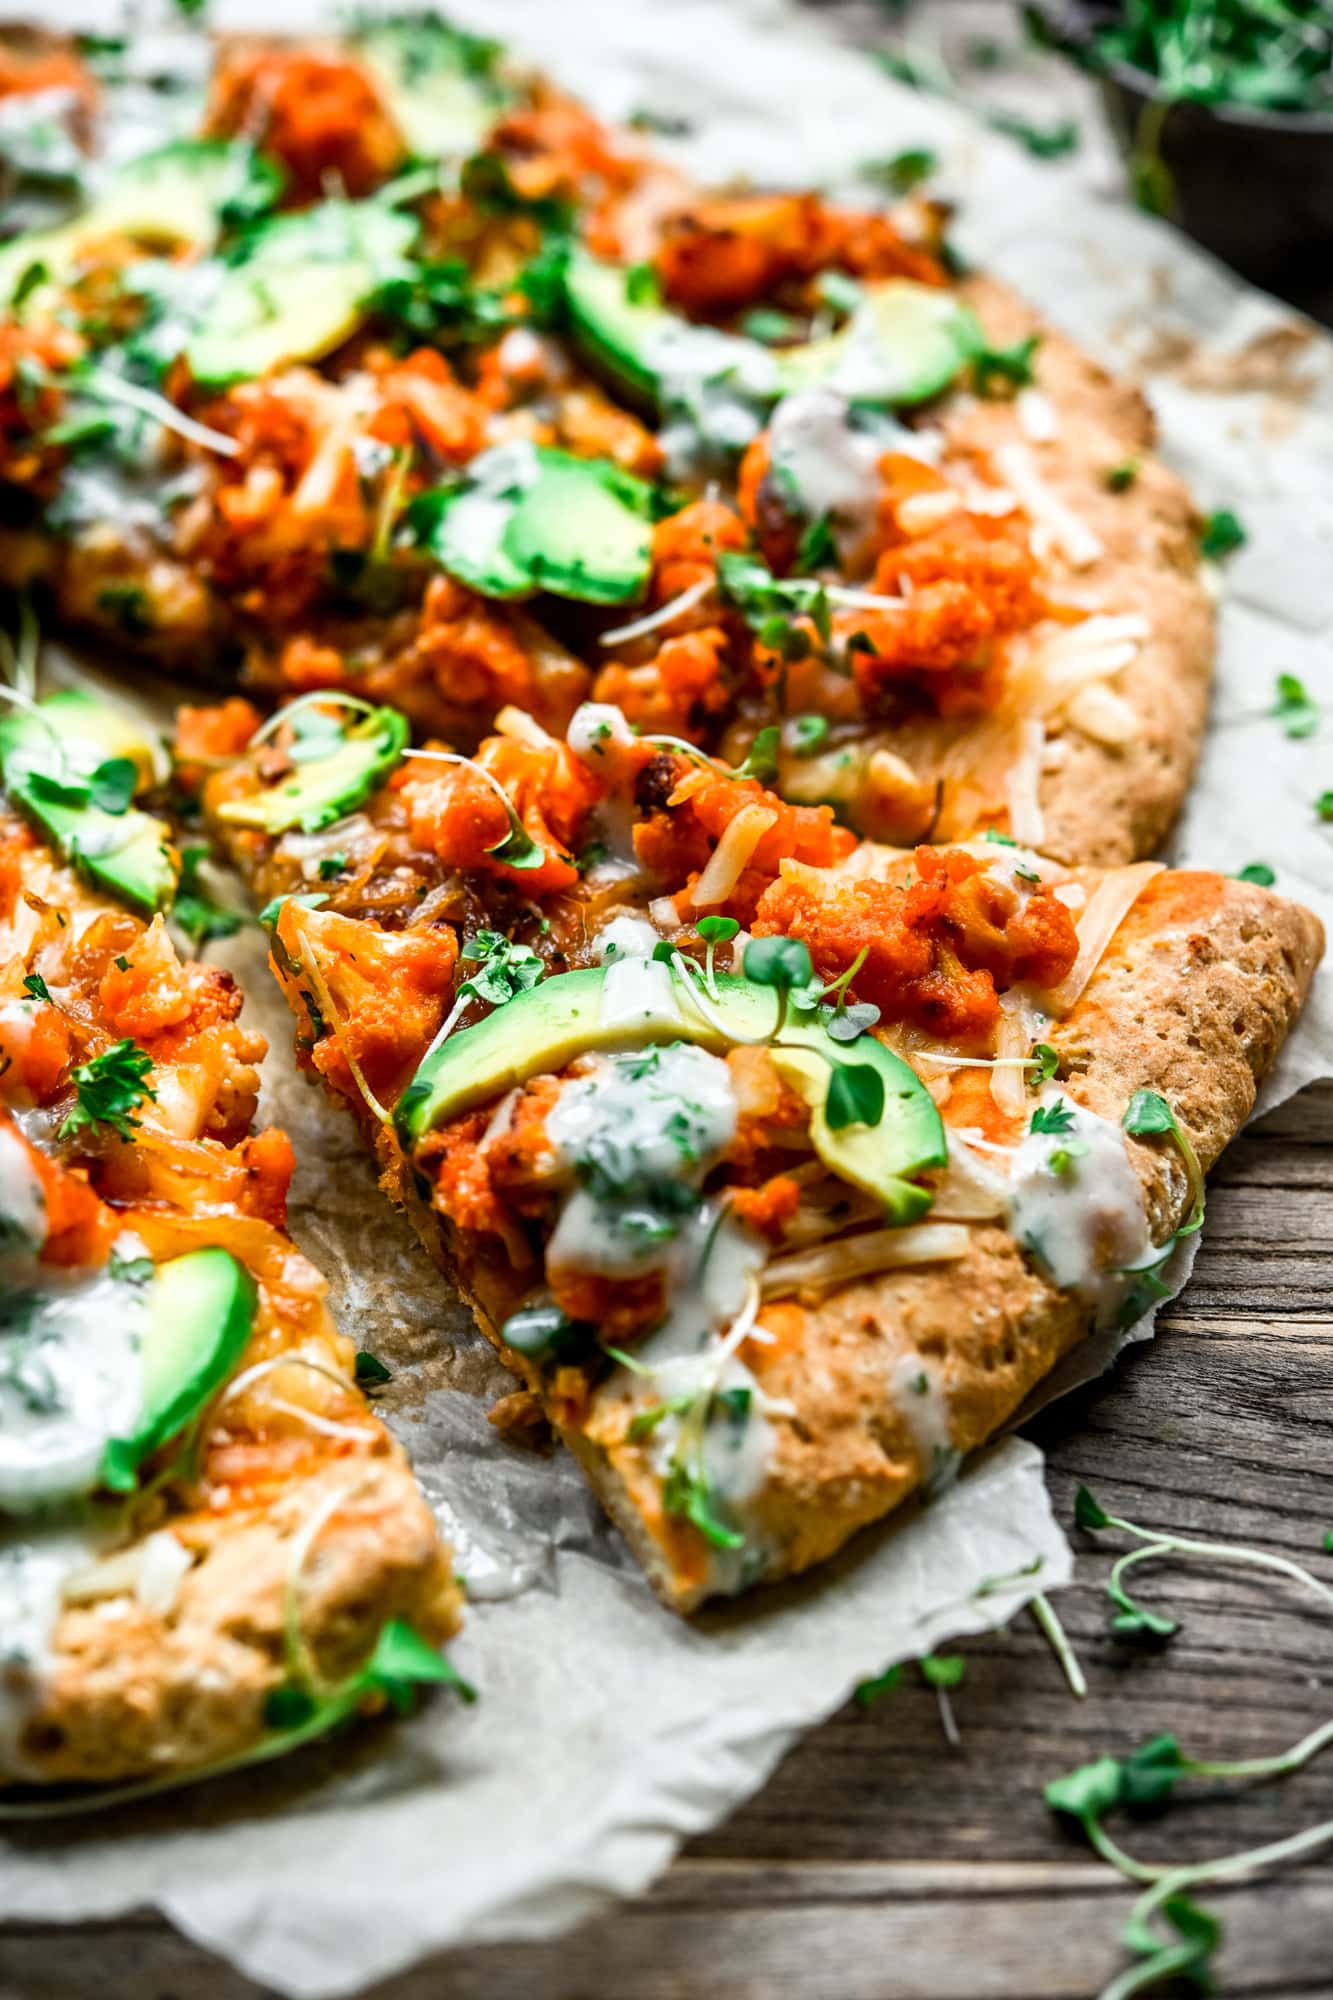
[195, 698, 1323, 1610]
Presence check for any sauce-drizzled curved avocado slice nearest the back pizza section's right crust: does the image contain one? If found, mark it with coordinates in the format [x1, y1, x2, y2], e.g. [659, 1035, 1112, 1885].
[564, 254, 983, 422]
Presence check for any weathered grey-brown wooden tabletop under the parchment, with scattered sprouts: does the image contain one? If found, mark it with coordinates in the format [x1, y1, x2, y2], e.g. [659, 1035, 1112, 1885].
[0, 1086, 1333, 2000]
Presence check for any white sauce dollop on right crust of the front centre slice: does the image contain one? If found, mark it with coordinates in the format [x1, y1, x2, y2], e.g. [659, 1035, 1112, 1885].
[1009, 1084, 1153, 1320]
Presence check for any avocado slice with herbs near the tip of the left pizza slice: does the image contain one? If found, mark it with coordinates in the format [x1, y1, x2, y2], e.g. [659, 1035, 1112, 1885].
[0, 688, 180, 916]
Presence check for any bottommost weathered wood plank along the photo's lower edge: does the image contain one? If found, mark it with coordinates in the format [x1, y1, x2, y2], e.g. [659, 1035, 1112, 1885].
[0, 1862, 1333, 2000]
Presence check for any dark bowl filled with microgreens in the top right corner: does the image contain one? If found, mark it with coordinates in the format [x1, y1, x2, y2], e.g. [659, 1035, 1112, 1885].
[1029, 0, 1333, 314]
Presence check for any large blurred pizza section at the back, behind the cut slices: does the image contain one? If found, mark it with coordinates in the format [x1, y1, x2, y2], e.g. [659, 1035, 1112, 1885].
[0, 16, 1213, 864]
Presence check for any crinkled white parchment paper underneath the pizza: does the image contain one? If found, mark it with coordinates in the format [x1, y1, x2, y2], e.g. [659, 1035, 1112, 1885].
[0, 0, 1333, 1996]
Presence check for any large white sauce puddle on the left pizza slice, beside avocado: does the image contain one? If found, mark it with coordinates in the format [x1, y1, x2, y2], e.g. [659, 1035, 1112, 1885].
[0, 1234, 148, 1514]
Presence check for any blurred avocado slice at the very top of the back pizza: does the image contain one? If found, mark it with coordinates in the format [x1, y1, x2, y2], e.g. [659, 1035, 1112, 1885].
[350, 14, 512, 160]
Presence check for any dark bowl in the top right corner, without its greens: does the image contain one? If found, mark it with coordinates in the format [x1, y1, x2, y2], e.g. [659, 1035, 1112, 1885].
[1035, 0, 1333, 320]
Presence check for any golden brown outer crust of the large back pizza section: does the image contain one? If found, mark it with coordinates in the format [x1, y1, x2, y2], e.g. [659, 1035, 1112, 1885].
[880, 278, 1215, 868]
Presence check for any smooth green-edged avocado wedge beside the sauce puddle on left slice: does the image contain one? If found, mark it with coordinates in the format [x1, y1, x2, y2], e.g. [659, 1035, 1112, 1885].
[108, 1244, 258, 1484]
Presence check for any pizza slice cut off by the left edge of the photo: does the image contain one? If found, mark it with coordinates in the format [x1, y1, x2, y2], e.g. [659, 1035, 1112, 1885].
[0, 694, 460, 1810]
